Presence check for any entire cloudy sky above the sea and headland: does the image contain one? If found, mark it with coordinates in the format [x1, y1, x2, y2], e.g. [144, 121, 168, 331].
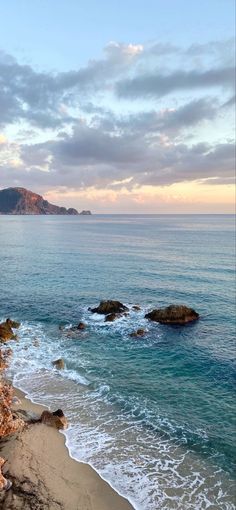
[0, 0, 235, 214]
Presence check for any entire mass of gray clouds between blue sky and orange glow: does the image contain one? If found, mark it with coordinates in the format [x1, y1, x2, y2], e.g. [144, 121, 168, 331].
[0, 41, 235, 189]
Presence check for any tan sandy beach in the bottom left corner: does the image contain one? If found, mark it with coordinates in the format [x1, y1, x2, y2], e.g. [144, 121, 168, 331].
[0, 390, 133, 510]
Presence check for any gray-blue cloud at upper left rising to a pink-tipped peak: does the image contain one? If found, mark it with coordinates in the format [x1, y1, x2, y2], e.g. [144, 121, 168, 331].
[0, 42, 142, 128]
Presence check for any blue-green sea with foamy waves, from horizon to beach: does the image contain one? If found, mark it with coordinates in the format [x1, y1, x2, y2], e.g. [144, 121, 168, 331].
[0, 215, 236, 510]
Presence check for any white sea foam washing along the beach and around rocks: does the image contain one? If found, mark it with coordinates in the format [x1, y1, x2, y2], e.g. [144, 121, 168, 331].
[4, 318, 235, 510]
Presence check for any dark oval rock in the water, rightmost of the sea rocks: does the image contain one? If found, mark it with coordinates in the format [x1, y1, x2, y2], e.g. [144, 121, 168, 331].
[145, 305, 199, 324]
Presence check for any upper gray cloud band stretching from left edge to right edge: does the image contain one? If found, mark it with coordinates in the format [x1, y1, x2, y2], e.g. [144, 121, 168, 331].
[0, 41, 234, 128]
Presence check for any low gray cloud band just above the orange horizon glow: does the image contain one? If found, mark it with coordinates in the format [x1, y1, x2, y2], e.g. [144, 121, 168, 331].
[0, 115, 232, 189]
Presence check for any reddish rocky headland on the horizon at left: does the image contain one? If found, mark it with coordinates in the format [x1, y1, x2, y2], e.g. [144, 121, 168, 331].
[0, 188, 91, 215]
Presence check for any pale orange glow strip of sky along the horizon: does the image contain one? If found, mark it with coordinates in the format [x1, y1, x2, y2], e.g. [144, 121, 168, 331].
[45, 181, 235, 214]
